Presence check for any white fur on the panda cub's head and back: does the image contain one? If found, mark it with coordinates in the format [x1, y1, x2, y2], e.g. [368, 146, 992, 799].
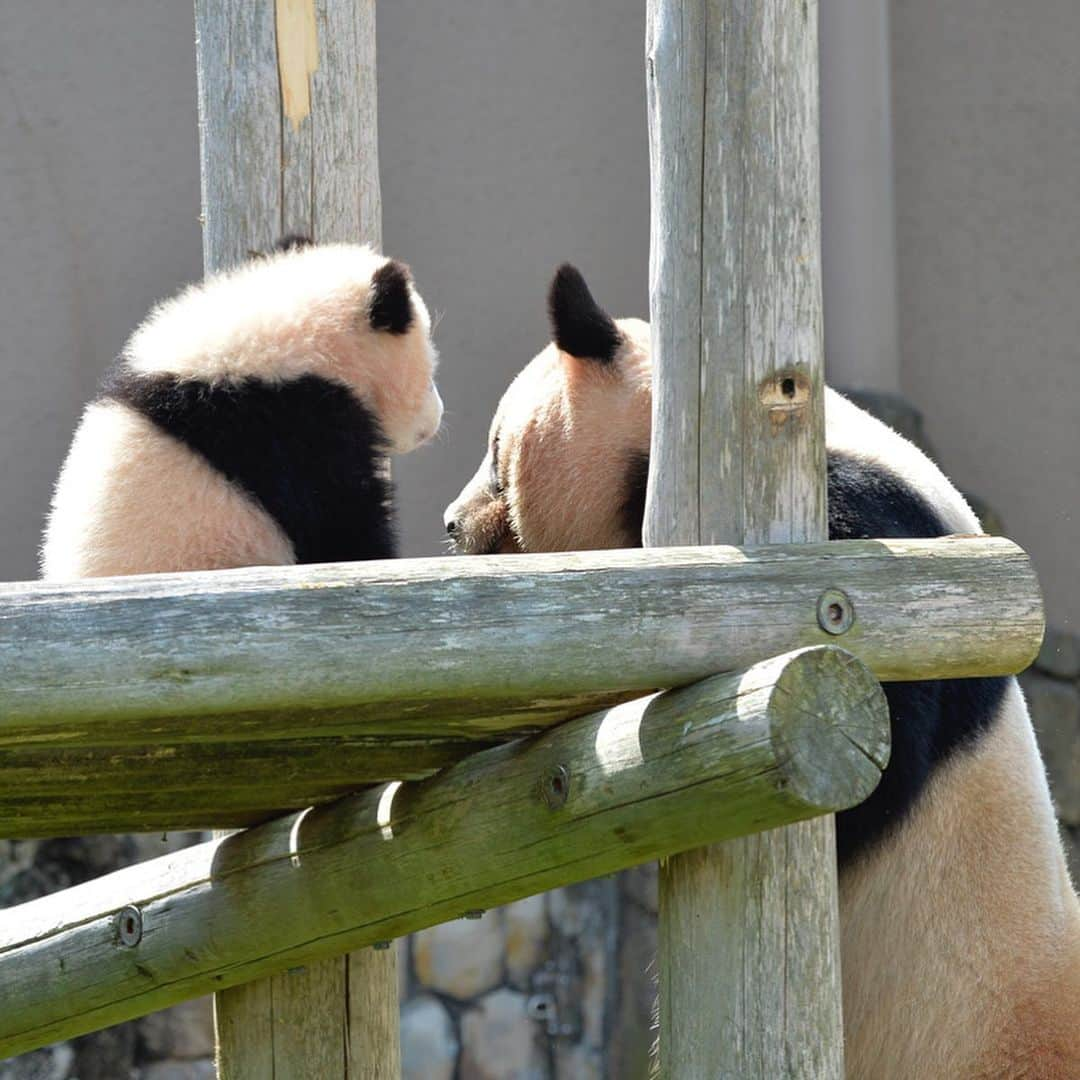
[41, 244, 443, 579]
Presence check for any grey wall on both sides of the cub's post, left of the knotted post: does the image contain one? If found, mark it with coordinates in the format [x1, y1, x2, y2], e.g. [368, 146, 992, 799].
[0, 0, 648, 579]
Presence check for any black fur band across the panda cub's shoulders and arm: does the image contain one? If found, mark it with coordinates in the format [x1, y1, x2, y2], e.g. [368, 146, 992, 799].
[99, 364, 396, 563]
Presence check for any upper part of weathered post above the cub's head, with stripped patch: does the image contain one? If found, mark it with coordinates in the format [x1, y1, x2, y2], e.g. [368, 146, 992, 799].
[195, 0, 382, 273]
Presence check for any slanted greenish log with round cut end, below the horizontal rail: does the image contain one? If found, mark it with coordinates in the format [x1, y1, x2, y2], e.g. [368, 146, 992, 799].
[0, 647, 888, 1058]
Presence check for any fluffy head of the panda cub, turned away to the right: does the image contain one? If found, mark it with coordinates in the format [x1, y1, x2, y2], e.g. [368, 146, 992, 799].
[123, 237, 443, 454]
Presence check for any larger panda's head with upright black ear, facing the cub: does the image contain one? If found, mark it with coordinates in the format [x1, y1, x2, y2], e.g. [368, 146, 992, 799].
[445, 265, 651, 554]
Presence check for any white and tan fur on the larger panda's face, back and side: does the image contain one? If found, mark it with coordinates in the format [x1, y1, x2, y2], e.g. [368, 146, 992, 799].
[446, 306, 1080, 1080]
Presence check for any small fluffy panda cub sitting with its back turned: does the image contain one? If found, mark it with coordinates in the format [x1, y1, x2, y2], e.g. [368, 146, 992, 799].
[41, 243, 443, 579]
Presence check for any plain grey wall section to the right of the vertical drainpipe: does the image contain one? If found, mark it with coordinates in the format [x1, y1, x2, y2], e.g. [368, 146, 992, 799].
[892, 0, 1080, 632]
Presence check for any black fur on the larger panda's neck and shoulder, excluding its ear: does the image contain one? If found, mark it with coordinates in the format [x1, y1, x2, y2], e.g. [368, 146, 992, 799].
[624, 442, 1009, 865]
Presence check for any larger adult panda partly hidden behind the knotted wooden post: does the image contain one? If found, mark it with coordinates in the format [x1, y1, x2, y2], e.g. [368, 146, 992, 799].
[445, 266, 1080, 1080]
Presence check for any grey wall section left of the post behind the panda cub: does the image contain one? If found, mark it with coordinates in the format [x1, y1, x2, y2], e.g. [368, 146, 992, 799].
[0, 0, 202, 579]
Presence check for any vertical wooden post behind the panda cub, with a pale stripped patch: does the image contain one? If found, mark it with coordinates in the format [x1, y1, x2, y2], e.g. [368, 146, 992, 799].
[195, 0, 401, 1080]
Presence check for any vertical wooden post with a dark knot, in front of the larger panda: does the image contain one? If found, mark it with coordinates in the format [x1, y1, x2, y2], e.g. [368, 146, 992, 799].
[645, 0, 843, 1080]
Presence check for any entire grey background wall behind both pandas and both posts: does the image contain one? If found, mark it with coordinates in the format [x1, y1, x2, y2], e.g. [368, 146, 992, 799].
[0, 0, 1080, 624]
